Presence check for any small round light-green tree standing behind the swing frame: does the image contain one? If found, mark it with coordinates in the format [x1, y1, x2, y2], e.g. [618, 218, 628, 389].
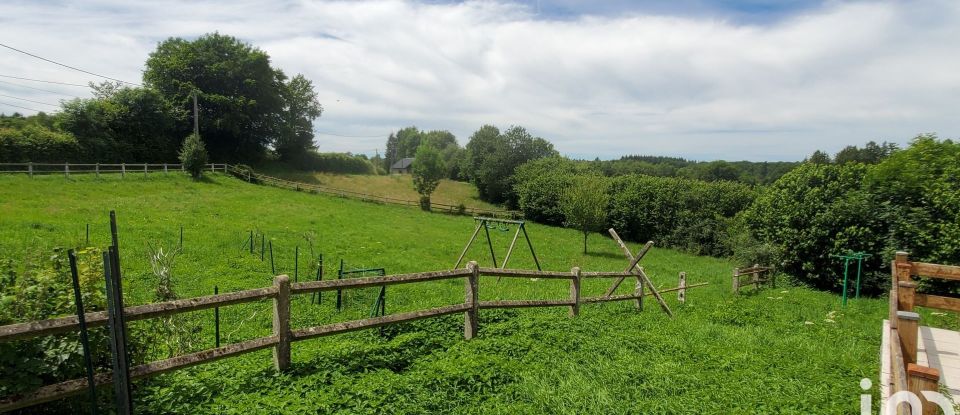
[561, 176, 610, 254]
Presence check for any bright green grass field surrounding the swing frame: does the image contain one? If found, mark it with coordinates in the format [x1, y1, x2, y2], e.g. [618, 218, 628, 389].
[0, 175, 900, 414]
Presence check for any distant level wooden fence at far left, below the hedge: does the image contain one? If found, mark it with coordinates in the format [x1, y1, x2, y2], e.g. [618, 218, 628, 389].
[0, 163, 227, 177]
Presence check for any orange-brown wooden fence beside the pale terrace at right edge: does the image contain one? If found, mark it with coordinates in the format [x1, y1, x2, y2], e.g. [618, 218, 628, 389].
[889, 252, 960, 415]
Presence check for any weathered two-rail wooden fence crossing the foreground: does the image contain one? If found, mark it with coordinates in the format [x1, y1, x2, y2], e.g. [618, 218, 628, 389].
[0, 262, 706, 412]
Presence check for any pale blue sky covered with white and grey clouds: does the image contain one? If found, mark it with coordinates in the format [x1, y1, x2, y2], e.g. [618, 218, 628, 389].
[0, 0, 960, 161]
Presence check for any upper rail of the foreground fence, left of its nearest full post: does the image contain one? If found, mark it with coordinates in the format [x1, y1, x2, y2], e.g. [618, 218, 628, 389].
[0, 287, 277, 341]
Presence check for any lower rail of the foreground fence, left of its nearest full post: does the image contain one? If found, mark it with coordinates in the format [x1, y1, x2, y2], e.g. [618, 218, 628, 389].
[0, 336, 278, 412]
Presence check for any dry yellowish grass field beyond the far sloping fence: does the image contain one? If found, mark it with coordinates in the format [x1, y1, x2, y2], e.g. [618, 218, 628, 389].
[263, 169, 500, 213]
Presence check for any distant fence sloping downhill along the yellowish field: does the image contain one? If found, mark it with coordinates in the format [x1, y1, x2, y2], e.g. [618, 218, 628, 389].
[226, 165, 523, 219]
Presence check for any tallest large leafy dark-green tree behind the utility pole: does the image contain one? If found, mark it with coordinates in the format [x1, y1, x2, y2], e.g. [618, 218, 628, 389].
[143, 33, 322, 161]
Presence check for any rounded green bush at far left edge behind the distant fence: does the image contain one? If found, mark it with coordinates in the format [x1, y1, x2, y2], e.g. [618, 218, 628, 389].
[0, 124, 80, 163]
